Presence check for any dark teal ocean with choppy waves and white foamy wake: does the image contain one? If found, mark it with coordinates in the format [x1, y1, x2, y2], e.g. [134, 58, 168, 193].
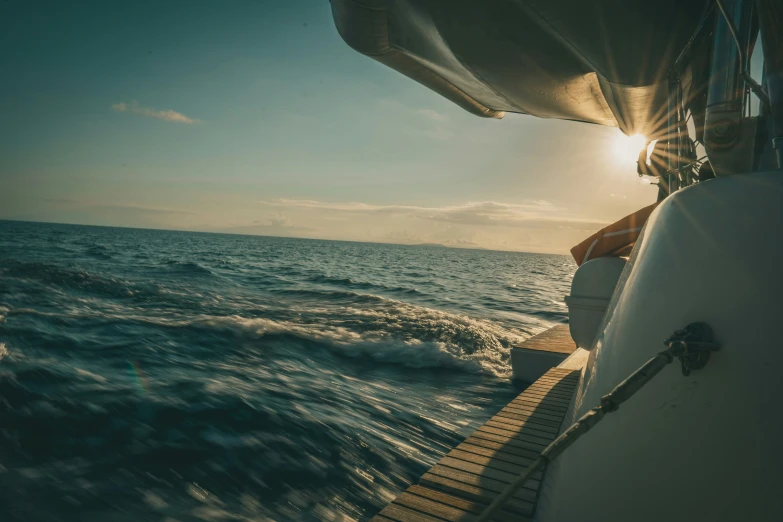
[0, 221, 576, 522]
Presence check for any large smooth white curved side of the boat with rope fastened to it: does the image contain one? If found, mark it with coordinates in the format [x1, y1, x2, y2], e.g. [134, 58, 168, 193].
[536, 172, 783, 522]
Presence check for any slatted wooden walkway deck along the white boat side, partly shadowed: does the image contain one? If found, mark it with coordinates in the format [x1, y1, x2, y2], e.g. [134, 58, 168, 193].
[372, 368, 580, 522]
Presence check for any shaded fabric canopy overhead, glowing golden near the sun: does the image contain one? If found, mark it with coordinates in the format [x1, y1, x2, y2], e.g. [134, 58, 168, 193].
[332, 0, 708, 137]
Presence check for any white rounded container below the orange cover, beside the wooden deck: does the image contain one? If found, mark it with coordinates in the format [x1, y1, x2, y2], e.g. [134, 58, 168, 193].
[565, 257, 626, 350]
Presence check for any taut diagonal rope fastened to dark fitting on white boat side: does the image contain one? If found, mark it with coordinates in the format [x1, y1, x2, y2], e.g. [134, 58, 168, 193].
[477, 323, 719, 522]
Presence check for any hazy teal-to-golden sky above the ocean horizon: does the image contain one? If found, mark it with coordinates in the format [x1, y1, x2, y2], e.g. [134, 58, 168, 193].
[0, 0, 657, 253]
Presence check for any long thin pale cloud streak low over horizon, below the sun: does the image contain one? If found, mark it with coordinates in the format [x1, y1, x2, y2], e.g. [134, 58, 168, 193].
[261, 199, 605, 231]
